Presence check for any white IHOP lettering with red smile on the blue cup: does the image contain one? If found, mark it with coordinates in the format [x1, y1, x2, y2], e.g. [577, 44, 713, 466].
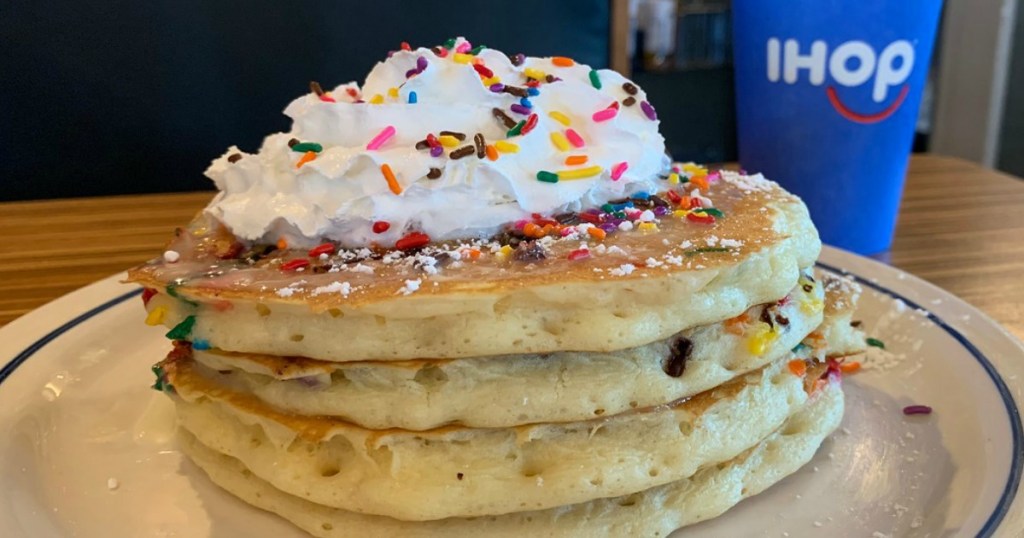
[768, 38, 913, 123]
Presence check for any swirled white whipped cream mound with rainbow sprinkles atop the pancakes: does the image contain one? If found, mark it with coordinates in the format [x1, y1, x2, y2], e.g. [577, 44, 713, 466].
[206, 38, 670, 247]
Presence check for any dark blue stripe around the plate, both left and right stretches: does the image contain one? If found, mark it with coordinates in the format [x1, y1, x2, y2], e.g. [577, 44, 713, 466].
[0, 262, 1024, 538]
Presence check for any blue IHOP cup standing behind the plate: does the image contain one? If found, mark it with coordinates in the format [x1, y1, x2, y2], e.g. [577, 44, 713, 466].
[732, 0, 942, 254]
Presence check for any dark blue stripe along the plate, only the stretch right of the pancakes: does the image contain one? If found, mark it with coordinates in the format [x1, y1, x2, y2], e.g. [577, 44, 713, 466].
[816, 261, 1024, 538]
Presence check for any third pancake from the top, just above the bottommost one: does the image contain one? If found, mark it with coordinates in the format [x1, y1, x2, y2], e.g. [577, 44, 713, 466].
[164, 357, 823, 521]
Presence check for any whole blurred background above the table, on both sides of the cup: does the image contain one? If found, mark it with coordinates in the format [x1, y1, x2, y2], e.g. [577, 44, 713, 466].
[0, 0, 1024, 201]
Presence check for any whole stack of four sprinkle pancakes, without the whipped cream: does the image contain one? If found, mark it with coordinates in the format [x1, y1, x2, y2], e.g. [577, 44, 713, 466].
[130, 172, 863, 537]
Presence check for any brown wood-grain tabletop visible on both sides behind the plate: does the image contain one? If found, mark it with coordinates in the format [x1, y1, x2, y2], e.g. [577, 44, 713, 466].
[0, 155, 1024, 339]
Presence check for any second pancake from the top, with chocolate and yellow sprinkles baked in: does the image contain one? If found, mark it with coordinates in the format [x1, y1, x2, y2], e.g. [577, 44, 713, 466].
[186, 270, 863, 430]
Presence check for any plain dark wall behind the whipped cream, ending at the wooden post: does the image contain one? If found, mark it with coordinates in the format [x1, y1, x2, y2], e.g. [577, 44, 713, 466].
[0, 0, 609, 200]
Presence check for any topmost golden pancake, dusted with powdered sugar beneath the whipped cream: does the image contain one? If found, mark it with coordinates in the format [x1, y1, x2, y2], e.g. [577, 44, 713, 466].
[129, 173, 820, 362]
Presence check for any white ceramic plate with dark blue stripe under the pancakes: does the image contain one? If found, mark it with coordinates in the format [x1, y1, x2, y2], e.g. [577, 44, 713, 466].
[0, 244, 1024, 538]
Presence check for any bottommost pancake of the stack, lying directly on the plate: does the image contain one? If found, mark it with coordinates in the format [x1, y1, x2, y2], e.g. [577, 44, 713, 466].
[178, 375, 843, 538]
